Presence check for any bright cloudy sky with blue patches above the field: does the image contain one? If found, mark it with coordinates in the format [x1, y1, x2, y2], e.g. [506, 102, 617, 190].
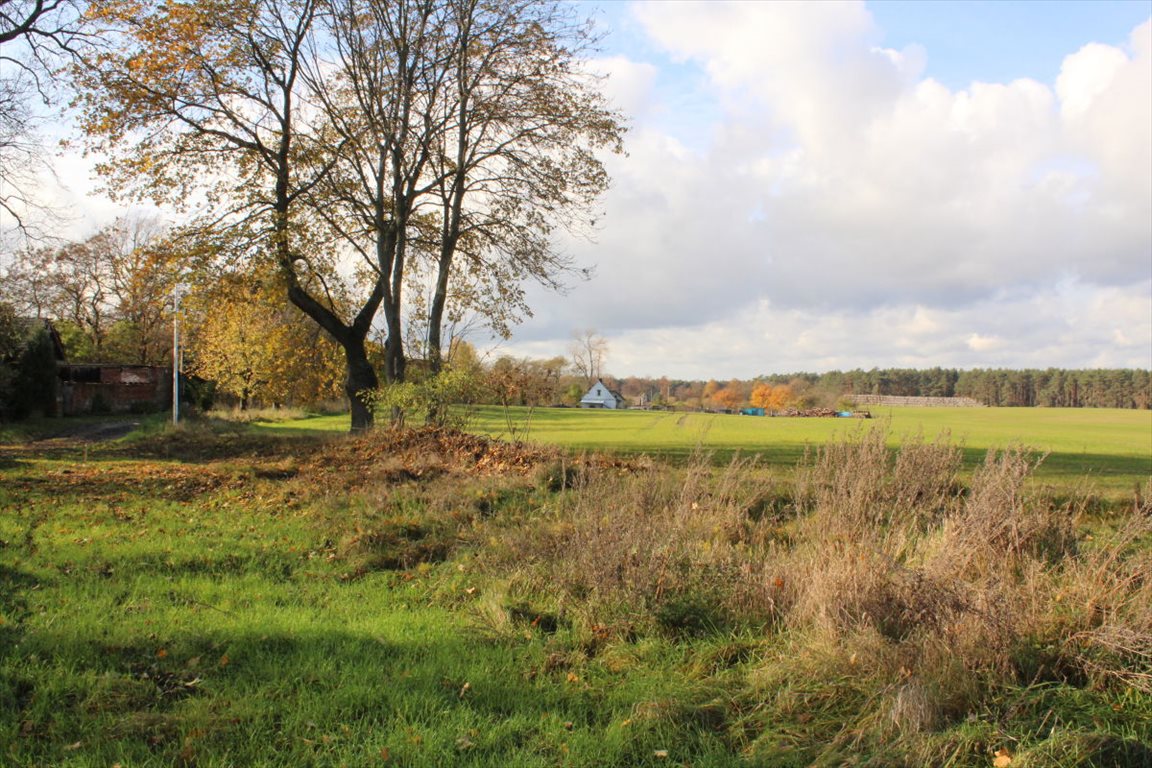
[11, 0, 1152, 380]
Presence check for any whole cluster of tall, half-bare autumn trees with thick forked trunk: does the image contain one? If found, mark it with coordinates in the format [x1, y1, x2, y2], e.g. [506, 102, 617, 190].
[77, 0, 620, 429]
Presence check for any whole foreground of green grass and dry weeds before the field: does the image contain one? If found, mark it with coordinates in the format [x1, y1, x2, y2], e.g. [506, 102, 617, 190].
[0, 424, 1152, 768]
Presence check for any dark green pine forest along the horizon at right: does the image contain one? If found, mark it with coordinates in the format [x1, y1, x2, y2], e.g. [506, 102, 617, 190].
[760, 367, 1152, 409]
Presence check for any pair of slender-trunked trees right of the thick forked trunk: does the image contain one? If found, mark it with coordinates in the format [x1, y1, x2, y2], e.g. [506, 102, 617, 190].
[310, 0, 622, 380]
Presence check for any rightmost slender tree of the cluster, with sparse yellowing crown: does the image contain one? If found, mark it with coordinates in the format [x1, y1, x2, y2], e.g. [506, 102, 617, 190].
[429, 0, 622, 370]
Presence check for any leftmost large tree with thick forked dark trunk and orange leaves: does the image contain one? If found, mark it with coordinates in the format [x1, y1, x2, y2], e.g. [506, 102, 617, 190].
[75, 0, 385, 431]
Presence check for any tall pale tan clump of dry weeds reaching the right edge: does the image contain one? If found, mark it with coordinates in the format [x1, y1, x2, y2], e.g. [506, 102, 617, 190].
[746, 431, 1152, 754]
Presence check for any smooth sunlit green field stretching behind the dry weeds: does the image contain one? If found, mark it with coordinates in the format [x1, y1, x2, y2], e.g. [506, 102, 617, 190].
[262, 406, 1152, 497]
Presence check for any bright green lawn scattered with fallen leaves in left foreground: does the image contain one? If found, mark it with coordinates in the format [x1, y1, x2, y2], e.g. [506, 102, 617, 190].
[0, 446, 732, 768]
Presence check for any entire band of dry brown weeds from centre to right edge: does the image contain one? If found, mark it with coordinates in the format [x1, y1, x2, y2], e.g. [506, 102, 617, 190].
[479, 431, 1152, 765]
